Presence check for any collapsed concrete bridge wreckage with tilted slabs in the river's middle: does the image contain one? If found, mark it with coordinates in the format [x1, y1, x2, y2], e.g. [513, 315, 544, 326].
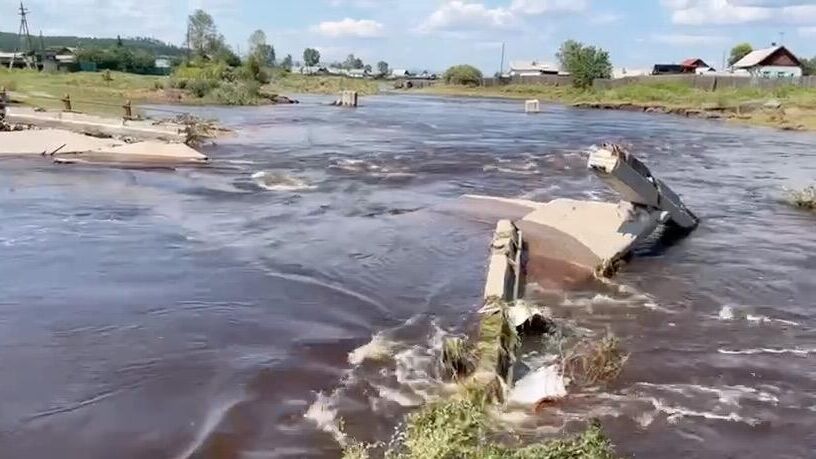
[452, 145, 699, 404]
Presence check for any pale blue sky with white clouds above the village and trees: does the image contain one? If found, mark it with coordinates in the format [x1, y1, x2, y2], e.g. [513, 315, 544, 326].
[0, 0, 816, 73]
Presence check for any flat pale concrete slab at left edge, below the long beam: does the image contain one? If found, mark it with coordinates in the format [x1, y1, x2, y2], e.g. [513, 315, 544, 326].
[0, 129, 124, 155]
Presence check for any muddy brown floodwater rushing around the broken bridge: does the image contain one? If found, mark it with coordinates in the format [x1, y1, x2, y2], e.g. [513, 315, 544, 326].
[0, 96, 816, 459]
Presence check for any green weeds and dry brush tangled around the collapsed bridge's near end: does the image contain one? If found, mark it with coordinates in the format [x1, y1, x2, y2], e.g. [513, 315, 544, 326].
[343, 299, 627, 459]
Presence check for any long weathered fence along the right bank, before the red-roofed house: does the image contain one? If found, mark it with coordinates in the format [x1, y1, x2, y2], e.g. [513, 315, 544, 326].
[592, 75, 816, 91]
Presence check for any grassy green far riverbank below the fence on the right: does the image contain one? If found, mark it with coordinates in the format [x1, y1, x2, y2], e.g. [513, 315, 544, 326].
[416, 83, 816, 131]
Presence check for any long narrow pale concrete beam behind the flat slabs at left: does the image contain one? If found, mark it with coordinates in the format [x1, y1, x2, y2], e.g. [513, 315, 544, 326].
[6, 107, 187, 142]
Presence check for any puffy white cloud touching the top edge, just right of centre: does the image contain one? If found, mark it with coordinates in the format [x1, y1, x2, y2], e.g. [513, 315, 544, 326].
[418, 0, 516, 32]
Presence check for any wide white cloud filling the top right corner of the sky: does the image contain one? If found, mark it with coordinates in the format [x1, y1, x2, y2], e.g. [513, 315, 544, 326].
[662, 0, 816, 25]
